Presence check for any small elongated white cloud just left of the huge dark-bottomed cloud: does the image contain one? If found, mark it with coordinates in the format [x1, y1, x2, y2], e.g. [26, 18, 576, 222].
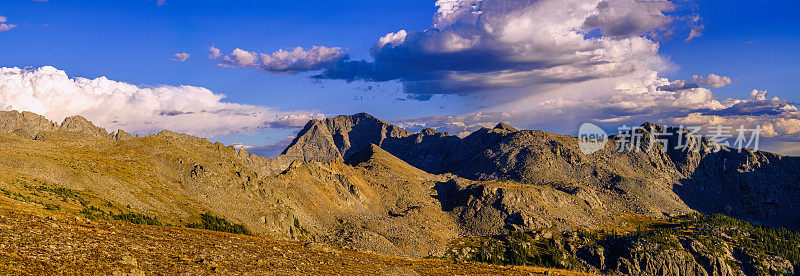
[209, 46, 346, 73]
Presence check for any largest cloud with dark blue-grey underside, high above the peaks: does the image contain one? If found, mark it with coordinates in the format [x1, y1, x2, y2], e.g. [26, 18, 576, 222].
[316, 0, 700, 95]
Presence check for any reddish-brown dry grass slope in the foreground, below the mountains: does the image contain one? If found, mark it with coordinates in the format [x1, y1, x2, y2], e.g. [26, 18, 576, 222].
[0, 206, 580, 275]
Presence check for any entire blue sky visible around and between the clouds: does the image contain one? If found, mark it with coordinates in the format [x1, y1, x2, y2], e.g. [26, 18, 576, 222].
[0, 0, 800, 154]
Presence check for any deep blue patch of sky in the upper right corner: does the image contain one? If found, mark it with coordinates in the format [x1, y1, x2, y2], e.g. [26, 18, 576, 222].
[661, 1, 800, 101]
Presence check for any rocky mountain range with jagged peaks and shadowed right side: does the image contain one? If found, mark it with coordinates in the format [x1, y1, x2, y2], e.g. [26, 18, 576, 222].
[0, 111, 800, 275]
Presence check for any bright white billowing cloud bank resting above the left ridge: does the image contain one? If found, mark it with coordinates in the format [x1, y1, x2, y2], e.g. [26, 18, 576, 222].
[0, 66, 322, 137]
